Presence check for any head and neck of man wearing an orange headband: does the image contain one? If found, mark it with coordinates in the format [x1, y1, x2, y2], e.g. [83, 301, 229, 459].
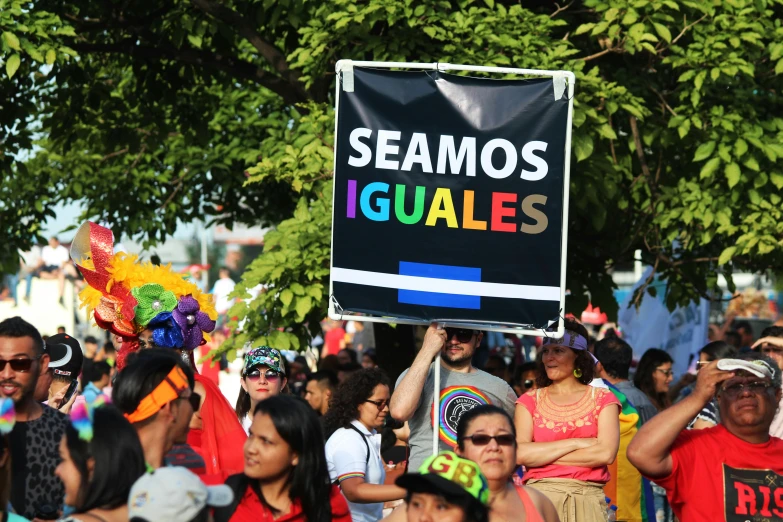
[112, 348, 203, 469]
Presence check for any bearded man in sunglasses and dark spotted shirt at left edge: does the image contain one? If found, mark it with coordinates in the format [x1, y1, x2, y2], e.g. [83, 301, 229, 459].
[0, 317, 68, 520]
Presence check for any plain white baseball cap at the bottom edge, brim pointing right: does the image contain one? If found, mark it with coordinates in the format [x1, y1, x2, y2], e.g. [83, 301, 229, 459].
[128, 467, 234, 522]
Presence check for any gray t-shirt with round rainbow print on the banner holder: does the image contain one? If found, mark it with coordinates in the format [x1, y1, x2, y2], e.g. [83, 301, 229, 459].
[396, 363, 517, 472]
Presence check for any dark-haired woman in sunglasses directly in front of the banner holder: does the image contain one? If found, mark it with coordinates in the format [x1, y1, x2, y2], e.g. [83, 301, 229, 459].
[457, 404, 558, 522]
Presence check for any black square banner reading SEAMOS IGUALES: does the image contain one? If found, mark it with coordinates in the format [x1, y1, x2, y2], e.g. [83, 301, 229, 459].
[331, 64, 570, 327]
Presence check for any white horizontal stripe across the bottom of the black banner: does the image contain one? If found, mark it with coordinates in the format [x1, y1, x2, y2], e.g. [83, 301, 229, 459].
[331, 267, 560, 308]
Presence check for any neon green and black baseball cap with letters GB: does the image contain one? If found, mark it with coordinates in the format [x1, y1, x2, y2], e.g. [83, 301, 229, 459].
[395, 451, 489, 506]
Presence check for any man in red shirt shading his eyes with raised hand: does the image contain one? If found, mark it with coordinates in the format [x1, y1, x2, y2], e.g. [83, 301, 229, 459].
[628, 353, 783, 522]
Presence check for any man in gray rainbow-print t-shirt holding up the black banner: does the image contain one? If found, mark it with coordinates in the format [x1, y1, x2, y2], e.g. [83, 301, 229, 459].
[389, 323, 517, 469]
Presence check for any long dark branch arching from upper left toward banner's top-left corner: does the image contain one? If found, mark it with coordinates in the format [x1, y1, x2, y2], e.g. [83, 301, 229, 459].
[71, 37, 306, 104]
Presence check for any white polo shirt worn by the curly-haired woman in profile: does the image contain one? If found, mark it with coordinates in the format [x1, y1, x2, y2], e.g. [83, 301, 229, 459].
[326, 420, 386, 522]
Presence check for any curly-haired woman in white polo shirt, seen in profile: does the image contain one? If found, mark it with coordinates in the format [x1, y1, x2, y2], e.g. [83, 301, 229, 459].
[324, 368, 405, 522]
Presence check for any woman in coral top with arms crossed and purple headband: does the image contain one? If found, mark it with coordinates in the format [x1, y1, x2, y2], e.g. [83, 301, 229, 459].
[515, 319, 620, 522]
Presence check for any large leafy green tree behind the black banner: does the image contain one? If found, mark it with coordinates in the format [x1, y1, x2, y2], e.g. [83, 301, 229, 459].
[1, 0, 783, 358]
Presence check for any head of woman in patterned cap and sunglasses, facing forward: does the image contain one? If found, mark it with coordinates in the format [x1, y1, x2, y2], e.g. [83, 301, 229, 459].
[236, 346, 288, 431]
